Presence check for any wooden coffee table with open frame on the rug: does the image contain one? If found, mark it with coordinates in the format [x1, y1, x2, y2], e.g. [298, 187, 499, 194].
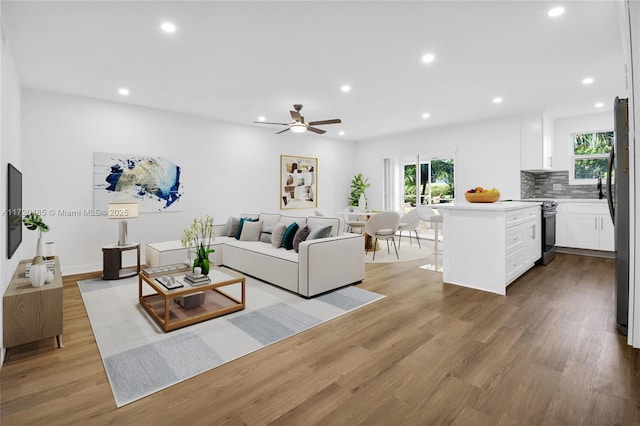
[138, 268, 246, 331]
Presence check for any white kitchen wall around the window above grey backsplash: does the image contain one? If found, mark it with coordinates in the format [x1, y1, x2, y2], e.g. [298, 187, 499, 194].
[553, 111, 613, 170]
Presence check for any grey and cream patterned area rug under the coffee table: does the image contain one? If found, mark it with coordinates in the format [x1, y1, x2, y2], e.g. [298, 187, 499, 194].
[78, 277, 384, 407]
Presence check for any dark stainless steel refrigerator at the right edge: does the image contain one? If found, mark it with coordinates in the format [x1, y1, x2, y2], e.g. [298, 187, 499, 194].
[607, 98, 629, 336]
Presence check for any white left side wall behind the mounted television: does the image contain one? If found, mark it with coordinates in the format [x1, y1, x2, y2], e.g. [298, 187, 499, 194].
[0, 8, 21, 365]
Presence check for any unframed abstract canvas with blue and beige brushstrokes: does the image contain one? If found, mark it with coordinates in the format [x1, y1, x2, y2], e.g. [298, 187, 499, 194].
[93, 152, 183, 212]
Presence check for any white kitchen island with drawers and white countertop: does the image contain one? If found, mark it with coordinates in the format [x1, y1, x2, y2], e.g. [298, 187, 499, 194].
[440, 201, 542, 295]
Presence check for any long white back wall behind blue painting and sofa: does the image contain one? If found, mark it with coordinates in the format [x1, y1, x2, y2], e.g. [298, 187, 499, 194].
[22, 89, 356, 274]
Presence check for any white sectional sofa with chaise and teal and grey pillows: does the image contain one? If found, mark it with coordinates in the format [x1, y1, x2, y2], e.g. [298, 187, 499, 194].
[145, 213, 364, 297]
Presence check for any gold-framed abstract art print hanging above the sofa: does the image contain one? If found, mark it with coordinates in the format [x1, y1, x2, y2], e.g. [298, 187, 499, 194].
[280, 155, 318, 210]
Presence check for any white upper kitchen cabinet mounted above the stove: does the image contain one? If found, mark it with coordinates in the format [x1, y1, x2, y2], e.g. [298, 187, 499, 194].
[520, 113, 554, 171]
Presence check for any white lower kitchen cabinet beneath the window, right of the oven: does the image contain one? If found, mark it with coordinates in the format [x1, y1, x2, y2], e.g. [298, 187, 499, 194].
[556, 201, 615, 251]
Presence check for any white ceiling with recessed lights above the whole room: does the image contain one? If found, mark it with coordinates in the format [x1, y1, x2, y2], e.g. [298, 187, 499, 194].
[2, 0, 626, 140]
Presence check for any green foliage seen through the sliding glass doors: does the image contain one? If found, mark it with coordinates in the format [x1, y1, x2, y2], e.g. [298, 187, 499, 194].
[404, 159, 453, 206]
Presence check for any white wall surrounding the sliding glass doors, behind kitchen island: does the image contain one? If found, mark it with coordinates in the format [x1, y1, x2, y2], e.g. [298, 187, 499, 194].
[358, 116, 520, 209]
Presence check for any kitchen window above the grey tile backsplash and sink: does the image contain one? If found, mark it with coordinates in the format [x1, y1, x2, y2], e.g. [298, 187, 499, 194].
[569, 131, 613, 184]
